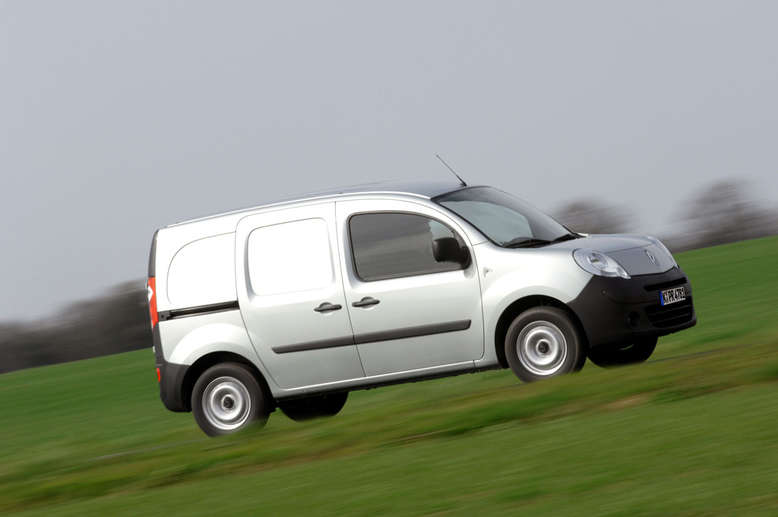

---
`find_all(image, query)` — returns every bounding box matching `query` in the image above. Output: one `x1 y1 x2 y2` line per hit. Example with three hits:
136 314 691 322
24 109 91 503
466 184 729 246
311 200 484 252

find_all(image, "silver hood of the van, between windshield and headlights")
553 234 675 276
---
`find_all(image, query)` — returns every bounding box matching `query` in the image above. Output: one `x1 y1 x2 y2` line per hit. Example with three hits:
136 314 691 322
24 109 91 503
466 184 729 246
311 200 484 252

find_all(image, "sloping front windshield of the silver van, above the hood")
435 187 577 248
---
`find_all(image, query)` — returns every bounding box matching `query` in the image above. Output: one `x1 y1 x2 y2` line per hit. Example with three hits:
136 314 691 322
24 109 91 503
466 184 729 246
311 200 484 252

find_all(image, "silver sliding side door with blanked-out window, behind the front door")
235 202 364 388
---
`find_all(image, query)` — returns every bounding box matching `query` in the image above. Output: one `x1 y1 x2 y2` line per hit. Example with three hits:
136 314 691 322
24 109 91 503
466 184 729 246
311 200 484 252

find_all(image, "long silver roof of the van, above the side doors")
168 181 463 227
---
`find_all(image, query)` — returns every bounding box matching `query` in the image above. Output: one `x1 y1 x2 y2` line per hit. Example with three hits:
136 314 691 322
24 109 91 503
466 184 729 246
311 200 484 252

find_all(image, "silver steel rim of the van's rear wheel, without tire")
202 377 251 431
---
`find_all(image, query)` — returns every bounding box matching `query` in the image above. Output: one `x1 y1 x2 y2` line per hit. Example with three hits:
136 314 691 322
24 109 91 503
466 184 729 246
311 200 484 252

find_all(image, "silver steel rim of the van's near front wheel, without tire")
516 321 567 376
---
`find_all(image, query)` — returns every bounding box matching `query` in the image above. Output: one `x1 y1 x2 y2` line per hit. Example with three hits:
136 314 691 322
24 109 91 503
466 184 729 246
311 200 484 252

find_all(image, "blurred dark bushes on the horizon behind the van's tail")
0 281 152 373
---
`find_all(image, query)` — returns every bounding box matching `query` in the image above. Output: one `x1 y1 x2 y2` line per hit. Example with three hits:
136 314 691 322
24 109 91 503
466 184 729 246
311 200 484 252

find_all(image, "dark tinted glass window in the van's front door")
349 212 462 282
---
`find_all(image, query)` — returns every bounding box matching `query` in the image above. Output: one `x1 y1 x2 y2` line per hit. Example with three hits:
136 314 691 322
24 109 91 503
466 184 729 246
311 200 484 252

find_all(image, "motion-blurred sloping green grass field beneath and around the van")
0 238 778 516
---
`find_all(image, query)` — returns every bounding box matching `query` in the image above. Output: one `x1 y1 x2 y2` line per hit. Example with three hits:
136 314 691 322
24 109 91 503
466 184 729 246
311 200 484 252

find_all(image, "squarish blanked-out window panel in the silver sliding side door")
248 218 335 296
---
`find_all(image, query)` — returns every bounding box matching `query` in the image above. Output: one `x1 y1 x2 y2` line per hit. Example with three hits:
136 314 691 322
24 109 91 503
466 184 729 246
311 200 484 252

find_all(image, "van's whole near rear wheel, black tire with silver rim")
192 363 272 436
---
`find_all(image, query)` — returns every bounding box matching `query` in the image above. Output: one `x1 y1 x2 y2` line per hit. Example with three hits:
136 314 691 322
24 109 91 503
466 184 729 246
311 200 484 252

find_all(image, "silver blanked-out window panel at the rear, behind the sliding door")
167 233 233 307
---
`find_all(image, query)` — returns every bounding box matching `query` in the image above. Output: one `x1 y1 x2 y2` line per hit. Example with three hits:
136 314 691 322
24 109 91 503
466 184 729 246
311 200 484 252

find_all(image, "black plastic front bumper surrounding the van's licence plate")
568 268 697 347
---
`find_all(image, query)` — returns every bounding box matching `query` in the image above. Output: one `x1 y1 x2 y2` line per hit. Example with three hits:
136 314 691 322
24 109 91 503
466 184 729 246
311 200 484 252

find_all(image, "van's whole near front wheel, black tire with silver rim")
505 306 586 382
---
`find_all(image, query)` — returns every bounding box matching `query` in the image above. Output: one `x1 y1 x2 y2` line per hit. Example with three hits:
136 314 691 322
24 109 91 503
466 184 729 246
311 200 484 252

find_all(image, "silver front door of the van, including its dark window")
336 199 484 376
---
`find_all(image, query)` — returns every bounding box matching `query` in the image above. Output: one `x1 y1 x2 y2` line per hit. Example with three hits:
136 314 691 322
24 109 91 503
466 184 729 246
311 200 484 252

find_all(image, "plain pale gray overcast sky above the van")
0 0 778 321
